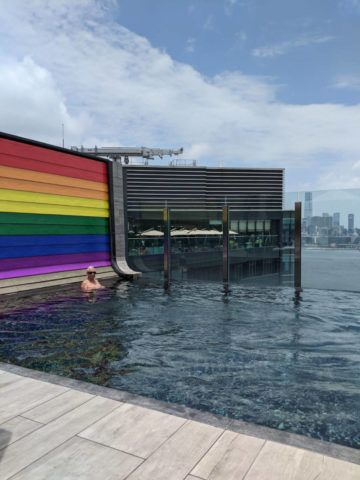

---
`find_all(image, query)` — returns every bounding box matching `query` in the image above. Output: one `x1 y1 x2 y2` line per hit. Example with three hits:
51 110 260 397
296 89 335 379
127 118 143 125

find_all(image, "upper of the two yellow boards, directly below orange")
0 188 109 209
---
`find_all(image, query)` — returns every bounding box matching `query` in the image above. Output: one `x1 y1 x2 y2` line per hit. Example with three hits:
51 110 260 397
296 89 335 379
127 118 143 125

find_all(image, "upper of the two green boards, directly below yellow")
0 212 109 227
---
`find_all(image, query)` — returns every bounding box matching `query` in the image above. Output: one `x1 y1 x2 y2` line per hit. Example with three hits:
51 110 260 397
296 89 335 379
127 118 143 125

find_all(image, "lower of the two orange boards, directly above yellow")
0 177 108 200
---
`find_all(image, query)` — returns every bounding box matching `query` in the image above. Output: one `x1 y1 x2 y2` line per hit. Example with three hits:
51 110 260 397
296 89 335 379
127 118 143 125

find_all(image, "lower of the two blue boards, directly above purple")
0 243 109 258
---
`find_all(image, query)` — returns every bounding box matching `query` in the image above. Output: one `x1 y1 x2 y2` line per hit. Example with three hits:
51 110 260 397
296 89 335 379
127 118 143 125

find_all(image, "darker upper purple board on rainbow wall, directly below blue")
0 252 110 272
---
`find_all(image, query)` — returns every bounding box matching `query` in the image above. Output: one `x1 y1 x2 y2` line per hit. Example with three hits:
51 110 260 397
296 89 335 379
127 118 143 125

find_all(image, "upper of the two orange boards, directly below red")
0 165 108 192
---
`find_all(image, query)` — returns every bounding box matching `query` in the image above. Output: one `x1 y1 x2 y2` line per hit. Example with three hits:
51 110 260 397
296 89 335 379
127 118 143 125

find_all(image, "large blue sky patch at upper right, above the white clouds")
116 0 360 105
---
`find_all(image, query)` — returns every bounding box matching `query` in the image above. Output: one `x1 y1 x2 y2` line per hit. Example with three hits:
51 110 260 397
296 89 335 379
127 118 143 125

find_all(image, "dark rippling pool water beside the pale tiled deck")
0 279 360 448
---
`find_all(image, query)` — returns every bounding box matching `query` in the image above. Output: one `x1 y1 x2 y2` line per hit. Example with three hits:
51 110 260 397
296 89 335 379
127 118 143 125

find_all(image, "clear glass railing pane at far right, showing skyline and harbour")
285 189 360 291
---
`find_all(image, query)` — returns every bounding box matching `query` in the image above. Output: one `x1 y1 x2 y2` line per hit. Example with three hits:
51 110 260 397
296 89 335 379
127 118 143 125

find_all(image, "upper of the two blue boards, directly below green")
0 235 109 247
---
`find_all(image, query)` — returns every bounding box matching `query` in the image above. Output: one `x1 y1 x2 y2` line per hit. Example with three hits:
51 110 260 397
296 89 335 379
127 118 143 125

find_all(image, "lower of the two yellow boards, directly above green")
0 201 109 218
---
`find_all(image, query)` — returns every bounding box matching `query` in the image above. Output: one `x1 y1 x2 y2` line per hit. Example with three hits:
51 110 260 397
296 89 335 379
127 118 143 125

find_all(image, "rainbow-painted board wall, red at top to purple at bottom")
0 133 110 279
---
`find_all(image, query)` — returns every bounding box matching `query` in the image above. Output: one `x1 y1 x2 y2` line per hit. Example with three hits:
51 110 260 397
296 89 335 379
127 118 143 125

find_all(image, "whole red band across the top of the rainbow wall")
0 138 107 183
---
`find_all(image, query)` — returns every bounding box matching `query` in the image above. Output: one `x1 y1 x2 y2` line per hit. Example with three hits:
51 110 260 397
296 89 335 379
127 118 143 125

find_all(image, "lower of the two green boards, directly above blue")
0 224 109 235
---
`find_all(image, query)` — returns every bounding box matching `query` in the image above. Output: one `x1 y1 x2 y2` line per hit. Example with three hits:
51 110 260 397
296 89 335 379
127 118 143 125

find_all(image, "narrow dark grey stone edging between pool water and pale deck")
0 362 360 465
